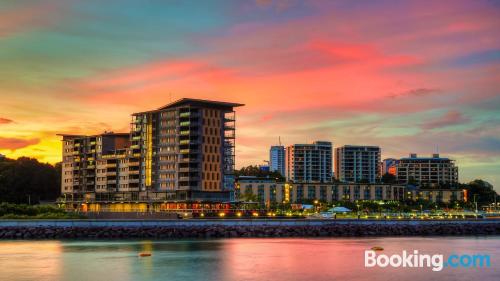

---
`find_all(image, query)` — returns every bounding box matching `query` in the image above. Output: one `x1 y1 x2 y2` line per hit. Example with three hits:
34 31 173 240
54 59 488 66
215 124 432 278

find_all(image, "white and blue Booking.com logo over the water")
365 250 491 271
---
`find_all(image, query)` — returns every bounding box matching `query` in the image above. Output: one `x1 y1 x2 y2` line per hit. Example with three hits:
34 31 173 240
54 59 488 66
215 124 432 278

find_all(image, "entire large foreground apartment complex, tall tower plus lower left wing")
62 99 242 201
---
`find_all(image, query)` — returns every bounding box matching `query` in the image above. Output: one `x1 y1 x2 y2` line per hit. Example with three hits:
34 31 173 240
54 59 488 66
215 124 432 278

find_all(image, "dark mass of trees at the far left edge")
0 157 61 204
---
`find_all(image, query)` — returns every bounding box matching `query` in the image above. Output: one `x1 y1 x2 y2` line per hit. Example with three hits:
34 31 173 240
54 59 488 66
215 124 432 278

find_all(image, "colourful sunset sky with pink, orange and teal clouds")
0 0 500 190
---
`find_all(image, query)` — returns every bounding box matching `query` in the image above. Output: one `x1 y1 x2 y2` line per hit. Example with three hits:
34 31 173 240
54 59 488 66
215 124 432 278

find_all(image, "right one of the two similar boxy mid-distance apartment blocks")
335 145 381 183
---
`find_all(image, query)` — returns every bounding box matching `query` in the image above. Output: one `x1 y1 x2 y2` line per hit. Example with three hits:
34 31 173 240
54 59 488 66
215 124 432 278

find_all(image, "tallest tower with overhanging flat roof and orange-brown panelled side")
131 99 242 200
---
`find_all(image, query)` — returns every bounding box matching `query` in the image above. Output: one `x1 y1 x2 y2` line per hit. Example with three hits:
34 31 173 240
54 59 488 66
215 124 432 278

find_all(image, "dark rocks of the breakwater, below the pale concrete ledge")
0 221 500 239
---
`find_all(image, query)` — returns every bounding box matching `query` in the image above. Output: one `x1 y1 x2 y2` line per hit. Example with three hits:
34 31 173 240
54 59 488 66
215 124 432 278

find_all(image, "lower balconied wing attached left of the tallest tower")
61 133 139 197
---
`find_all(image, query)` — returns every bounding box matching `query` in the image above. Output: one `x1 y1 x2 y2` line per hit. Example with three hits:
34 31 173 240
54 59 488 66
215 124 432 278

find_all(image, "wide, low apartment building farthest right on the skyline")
396 154 458 185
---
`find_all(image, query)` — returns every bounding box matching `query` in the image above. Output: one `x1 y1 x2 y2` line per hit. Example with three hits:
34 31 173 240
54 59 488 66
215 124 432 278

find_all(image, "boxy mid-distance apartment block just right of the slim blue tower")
285 141 332 182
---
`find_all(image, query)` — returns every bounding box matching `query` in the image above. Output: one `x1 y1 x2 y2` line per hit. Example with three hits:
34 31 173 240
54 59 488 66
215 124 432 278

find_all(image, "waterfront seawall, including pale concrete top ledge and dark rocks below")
0 219 500 239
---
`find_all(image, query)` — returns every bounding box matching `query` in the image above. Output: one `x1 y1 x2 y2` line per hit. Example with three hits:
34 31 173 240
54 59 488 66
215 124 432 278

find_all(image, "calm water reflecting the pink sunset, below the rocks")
0 237 500 281
